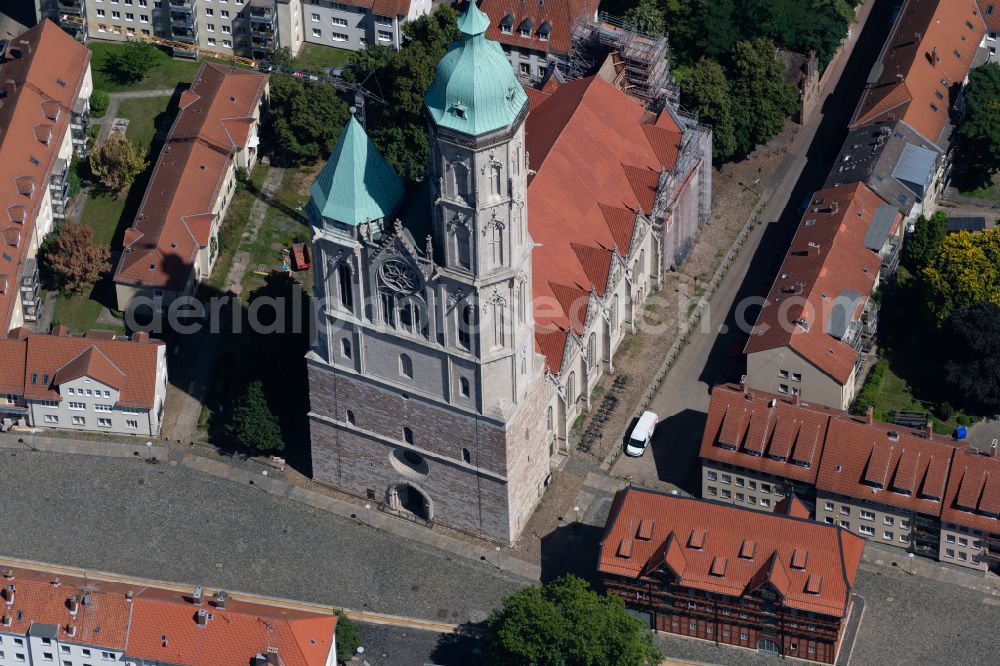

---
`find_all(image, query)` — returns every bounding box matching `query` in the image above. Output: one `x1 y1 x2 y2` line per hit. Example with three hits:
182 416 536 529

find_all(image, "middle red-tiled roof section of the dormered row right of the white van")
816 415 957 516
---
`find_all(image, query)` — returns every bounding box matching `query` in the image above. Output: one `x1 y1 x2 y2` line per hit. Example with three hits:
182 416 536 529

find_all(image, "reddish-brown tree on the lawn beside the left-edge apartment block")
43 224 111 291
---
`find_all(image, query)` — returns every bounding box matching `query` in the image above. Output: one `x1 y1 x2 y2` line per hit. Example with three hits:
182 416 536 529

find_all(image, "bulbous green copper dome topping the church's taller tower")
424 0 528 136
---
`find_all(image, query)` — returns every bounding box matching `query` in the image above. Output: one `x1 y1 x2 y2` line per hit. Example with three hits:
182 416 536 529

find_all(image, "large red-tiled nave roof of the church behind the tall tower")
525 76 679 372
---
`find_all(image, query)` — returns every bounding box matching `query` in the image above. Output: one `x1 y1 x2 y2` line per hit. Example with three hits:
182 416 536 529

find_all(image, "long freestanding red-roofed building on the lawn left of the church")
114 62 268 312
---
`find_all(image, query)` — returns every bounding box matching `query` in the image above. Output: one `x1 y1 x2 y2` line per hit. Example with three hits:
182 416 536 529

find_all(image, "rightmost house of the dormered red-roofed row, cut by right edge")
938 447 1000 571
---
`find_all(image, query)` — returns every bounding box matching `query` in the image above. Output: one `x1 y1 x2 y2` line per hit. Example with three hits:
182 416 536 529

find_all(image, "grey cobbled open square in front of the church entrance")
0 451 526 620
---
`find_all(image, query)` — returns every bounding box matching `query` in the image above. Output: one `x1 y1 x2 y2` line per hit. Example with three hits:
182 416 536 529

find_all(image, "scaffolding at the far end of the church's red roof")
568 12 677 103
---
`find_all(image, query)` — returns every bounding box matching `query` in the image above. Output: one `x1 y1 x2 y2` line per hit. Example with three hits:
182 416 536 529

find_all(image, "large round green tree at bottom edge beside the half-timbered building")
483 575 662 666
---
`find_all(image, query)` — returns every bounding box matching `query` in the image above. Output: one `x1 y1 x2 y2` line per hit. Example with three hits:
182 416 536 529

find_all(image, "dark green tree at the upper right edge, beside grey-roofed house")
959 62 1000 184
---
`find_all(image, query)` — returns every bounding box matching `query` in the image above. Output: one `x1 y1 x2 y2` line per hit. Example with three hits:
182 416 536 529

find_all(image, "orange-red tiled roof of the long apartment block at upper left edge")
0 19 90 333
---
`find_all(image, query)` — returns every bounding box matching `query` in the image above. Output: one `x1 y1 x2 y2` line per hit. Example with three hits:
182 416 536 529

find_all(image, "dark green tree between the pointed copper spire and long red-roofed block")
264 74 347 164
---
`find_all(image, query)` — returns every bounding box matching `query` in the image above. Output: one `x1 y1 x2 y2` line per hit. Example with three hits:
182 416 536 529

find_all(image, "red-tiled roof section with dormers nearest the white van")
699 384 843 484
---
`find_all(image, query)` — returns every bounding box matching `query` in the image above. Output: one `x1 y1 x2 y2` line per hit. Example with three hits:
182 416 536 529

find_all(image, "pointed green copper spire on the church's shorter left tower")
306 109 403 226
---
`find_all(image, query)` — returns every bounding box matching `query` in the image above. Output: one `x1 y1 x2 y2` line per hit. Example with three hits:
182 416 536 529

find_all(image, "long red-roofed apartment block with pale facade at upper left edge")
0 21 93 335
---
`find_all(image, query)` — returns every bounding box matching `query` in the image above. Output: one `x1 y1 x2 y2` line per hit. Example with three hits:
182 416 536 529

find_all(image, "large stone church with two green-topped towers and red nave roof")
307 3 711 543
